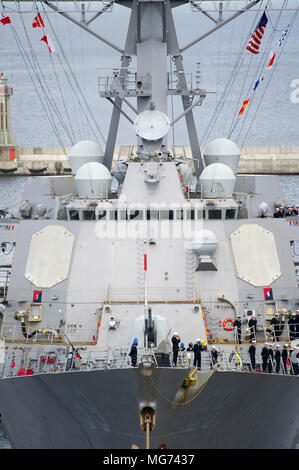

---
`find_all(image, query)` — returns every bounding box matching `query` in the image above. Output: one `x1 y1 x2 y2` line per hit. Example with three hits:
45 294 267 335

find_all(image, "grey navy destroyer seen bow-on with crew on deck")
0 0 299 449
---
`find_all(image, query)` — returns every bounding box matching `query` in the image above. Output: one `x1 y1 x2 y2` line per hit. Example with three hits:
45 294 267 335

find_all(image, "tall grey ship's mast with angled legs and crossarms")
2 0 268 172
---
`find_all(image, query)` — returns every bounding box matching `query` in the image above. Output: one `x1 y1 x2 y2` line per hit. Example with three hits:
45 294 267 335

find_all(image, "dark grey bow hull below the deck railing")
0 368 299 449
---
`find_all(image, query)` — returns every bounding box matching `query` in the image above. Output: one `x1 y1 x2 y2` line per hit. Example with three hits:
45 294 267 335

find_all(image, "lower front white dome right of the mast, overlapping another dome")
199 163 236 199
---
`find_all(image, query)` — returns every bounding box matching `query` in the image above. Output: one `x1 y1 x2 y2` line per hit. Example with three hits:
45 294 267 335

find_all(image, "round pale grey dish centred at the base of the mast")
134 109 170 141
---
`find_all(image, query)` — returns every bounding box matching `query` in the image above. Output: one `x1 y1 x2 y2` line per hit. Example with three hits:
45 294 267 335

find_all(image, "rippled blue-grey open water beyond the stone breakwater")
0 0 299 146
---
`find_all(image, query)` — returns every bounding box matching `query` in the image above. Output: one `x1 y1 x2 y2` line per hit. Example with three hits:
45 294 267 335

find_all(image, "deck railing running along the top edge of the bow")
0 345 299 378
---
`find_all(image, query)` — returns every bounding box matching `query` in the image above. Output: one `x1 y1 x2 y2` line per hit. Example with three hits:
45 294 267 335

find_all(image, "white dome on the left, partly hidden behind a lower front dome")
69 140 104 174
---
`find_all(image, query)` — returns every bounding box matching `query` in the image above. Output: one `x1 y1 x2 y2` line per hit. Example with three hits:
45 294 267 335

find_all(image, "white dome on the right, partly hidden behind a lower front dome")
204 138 240 173
